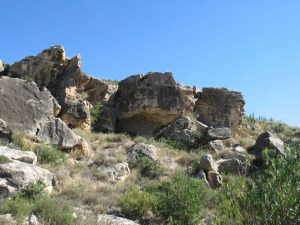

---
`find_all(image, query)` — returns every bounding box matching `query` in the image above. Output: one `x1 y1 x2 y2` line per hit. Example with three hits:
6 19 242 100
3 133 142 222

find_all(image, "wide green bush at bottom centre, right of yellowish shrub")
147 173 213 225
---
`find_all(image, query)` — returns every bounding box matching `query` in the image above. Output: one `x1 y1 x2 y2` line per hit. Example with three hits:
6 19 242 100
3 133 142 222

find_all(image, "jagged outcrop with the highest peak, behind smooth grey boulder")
8 45 90 129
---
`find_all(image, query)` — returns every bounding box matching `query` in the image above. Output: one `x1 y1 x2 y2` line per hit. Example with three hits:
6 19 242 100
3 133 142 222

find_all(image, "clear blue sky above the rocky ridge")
0 0 300 126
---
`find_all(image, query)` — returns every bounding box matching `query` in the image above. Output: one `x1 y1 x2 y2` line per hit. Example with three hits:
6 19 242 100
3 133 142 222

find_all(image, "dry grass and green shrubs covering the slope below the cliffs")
0 118 300 225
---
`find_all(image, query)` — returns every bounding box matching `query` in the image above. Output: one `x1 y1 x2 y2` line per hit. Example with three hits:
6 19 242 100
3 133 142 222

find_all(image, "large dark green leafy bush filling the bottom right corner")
220 143 300 225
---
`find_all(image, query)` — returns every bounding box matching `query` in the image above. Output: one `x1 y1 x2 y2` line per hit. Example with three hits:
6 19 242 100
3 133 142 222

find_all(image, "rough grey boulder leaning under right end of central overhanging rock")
156 116 201 148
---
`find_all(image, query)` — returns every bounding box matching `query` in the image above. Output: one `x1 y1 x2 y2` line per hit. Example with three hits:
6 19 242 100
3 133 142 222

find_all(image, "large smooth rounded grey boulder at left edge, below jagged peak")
0 77 56 136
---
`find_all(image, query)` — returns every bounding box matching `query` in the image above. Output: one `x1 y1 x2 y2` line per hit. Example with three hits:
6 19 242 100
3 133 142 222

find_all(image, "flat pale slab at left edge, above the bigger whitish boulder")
0 146 37 165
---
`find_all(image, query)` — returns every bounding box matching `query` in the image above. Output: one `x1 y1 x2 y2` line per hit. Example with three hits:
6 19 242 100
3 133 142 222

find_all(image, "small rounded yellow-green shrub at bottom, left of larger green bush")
118 187 155 220
